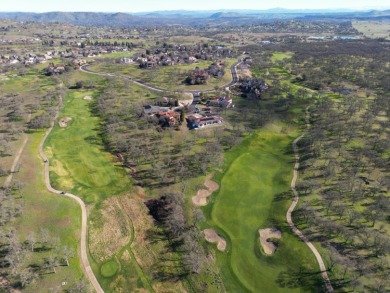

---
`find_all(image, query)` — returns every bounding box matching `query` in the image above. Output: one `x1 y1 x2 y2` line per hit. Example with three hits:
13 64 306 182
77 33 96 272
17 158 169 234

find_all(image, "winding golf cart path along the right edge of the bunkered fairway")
286 107 334 293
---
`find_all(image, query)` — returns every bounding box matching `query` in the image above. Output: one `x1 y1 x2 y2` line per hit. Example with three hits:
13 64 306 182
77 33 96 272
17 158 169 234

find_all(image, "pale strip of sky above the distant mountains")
0 0 390 12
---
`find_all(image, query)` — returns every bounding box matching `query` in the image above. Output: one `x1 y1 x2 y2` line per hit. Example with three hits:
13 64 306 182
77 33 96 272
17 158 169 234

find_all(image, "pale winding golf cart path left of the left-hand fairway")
39 101 104 293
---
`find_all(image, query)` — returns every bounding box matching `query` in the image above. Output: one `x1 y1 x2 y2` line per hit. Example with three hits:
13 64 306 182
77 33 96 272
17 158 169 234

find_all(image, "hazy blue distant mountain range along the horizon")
0 8 390 26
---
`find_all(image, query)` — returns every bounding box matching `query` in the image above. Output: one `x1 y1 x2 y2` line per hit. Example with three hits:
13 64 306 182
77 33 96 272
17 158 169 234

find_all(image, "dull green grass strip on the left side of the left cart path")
14 132 83 292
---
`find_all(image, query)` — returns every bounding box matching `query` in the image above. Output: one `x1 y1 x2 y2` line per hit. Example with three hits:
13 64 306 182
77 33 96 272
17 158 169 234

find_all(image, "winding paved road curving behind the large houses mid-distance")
80 62 241 94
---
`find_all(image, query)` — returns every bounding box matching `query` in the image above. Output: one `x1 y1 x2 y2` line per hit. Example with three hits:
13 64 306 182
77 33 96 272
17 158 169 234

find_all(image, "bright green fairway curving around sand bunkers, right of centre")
211 124 321 292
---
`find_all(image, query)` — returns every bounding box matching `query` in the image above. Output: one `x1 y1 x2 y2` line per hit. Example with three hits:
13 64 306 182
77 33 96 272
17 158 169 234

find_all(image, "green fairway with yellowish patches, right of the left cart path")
45 91 131 203
